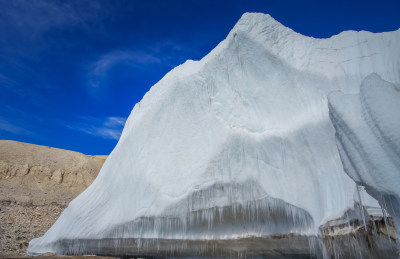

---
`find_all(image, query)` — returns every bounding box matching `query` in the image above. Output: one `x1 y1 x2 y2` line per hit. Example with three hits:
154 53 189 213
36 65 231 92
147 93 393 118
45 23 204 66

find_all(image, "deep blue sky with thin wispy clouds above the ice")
0 0 400 155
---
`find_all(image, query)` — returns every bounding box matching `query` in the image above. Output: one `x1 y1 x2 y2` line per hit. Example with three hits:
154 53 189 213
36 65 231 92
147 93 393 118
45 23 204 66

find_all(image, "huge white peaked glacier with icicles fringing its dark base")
27 13 400 258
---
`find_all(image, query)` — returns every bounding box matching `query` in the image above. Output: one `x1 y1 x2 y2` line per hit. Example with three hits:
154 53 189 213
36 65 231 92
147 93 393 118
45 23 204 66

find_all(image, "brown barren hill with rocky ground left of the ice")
0 140 107 257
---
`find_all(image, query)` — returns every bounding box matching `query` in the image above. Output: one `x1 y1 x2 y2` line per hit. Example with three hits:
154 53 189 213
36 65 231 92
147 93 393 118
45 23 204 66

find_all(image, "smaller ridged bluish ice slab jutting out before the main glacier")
329 74 400 244
